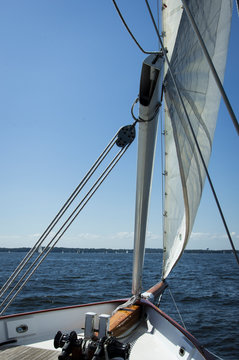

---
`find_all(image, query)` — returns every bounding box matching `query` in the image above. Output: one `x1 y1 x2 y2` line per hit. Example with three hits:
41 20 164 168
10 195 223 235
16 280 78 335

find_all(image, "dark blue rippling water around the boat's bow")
0 251 239 360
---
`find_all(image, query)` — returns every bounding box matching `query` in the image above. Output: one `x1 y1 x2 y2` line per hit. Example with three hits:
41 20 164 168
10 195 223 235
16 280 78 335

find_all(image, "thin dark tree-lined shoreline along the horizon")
0 247 235 254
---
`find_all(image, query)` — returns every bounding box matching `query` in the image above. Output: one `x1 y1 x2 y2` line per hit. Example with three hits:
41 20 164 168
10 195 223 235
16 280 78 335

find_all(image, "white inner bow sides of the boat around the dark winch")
0 300 214 360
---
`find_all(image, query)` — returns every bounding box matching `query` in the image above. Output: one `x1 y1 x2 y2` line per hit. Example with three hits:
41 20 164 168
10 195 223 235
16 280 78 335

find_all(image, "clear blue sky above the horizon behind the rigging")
0 0 239 249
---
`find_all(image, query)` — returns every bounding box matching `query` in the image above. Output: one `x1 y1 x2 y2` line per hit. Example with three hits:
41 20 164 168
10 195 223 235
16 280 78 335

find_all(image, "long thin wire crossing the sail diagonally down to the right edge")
145 0 239 265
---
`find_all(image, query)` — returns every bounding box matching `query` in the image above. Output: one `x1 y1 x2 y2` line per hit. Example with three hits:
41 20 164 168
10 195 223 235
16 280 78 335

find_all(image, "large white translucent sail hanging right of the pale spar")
162 0 232 278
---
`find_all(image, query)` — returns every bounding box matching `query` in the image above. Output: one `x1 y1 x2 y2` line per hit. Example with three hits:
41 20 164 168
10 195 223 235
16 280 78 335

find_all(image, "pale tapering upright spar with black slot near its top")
132 54 163 295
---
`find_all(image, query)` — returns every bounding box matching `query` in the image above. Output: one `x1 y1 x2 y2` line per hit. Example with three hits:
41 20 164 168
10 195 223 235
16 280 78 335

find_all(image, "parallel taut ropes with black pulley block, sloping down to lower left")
0 121 137 315
